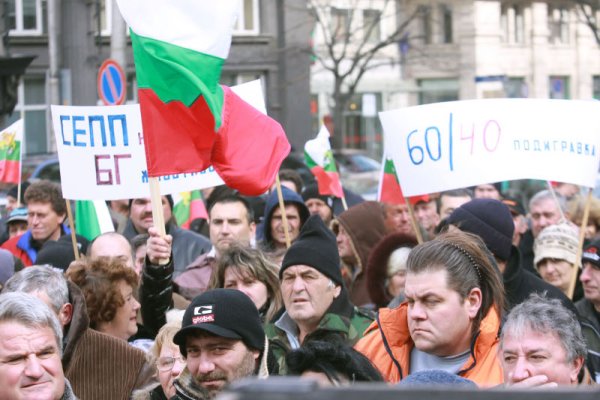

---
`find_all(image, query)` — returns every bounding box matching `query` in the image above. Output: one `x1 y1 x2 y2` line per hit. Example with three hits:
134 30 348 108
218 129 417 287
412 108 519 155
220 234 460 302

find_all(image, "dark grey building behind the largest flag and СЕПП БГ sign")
4 0 311 155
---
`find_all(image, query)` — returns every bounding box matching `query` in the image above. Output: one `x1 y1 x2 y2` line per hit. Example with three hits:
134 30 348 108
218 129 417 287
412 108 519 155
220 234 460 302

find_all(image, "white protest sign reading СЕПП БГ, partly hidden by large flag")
51 80 265 200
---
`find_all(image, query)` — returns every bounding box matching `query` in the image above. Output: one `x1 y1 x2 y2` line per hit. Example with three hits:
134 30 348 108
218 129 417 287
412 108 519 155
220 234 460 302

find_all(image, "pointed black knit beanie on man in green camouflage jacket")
279 215 343 285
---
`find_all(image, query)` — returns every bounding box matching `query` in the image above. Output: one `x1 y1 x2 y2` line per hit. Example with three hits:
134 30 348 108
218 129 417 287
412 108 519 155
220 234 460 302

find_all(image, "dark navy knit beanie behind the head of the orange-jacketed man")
448 199 515 261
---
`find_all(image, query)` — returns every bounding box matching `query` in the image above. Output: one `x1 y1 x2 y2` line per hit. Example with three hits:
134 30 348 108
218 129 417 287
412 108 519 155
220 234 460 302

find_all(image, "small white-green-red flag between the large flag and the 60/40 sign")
304 125 344 198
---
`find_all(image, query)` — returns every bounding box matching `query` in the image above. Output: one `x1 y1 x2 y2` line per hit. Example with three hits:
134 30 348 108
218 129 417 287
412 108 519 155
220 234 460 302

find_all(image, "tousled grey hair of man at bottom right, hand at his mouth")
500 293 587 362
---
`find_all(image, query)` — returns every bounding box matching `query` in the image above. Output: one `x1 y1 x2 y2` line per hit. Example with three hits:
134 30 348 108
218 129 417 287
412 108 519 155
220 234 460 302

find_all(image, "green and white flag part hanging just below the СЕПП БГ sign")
75 200 115 241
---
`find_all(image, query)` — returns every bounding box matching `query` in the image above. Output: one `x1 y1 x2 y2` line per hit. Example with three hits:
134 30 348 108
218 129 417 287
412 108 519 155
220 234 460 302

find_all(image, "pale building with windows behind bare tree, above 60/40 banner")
311 0 600 157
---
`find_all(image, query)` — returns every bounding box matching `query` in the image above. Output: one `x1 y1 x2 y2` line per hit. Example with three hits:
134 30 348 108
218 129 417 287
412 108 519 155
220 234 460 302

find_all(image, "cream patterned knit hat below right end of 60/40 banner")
533 222 581 268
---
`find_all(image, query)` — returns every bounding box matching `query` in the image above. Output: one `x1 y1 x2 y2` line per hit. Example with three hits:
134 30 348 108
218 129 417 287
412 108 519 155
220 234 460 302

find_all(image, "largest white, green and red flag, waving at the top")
117 0 290 195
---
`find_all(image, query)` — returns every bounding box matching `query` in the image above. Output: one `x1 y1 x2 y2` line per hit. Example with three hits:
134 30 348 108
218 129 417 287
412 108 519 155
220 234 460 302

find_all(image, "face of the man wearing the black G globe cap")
186 334 260 398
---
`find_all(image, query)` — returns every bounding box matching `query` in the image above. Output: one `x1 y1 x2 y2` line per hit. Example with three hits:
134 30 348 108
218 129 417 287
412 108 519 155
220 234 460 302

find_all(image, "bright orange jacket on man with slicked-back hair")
355 303 504 387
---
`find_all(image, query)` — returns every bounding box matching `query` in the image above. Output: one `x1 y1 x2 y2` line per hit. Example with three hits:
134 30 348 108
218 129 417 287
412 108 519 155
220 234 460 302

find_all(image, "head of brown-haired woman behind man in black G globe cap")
209 244 283 322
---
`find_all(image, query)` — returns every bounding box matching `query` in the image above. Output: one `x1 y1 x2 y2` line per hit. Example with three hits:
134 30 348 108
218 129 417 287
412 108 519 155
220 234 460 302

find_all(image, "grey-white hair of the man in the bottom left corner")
0 292 63 357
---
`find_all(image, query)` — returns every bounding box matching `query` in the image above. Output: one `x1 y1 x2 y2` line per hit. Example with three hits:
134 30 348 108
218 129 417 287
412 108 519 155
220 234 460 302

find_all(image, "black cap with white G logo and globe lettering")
173 289 265 356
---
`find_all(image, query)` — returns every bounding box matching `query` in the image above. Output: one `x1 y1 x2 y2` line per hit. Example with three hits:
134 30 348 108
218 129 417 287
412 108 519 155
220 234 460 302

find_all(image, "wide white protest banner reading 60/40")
379 99 600 196
